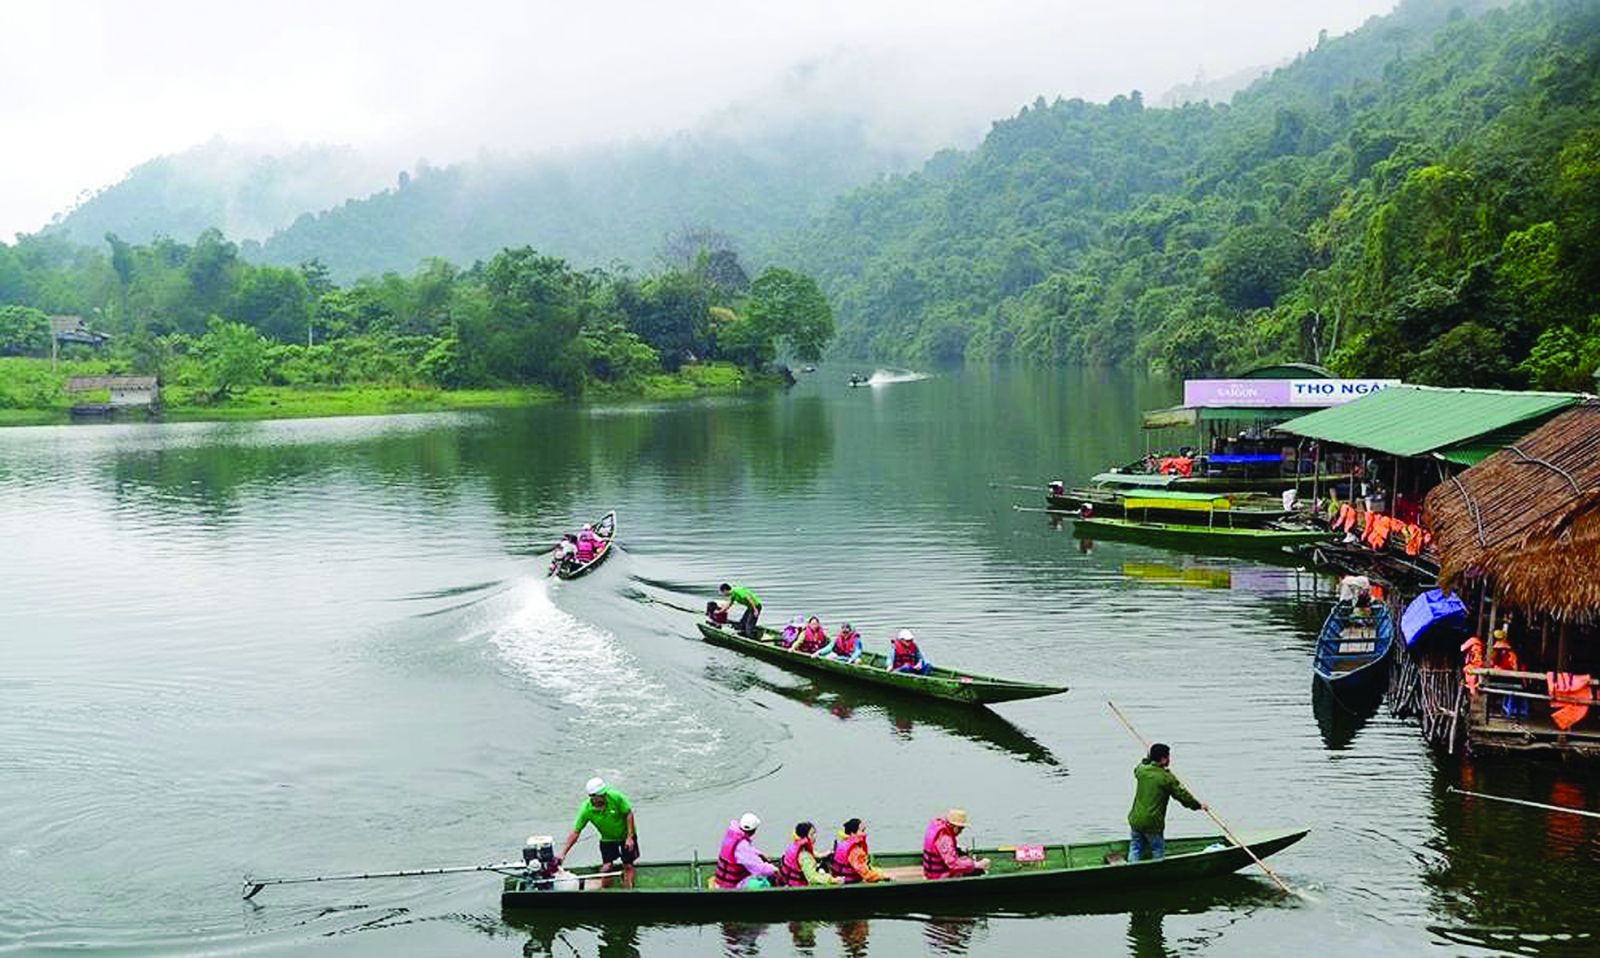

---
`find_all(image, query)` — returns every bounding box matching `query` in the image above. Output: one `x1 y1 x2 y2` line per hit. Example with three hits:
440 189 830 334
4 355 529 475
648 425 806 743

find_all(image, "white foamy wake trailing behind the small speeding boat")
490 579 722 758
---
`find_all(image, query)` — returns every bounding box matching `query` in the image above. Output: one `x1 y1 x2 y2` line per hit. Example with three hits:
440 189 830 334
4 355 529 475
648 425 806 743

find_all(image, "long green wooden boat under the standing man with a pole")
501 828 1307 921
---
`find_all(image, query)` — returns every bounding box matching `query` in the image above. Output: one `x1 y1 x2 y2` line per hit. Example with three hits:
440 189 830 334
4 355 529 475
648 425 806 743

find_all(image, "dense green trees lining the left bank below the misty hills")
0 230 834 406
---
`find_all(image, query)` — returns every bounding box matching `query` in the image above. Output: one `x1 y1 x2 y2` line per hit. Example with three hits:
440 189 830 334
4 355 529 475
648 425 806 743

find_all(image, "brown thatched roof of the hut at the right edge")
1426 400 1600 622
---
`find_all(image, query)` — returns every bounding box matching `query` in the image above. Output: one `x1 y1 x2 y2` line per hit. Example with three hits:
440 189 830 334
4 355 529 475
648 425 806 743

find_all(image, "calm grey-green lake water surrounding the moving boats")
0 369 1600 956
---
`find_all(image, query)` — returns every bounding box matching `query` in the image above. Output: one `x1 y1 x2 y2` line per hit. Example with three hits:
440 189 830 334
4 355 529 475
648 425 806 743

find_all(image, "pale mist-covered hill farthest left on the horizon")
43 139 394 246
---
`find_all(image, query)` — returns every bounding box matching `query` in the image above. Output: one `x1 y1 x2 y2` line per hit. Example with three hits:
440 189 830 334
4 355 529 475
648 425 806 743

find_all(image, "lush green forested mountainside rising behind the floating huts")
792 0 1600 385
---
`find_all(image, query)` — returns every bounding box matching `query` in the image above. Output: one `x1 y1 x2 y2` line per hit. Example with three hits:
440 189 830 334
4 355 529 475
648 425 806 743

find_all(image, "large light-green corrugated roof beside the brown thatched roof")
1277 385 1582 456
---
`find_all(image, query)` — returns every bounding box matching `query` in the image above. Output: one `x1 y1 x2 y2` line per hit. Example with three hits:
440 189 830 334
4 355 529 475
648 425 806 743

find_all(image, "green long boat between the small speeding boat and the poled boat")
699 622 1067 705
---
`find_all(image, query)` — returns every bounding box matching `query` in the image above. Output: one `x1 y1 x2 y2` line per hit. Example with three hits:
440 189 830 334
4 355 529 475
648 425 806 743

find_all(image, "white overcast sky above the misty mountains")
0 0 1394 237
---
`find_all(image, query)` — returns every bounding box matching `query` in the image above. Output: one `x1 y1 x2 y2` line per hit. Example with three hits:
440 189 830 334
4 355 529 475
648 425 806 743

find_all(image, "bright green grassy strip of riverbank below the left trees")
0 357 776 425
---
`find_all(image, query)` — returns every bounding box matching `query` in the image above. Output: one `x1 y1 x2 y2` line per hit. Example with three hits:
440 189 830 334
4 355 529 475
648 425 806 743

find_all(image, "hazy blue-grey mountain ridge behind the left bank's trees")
245 115 918 278
